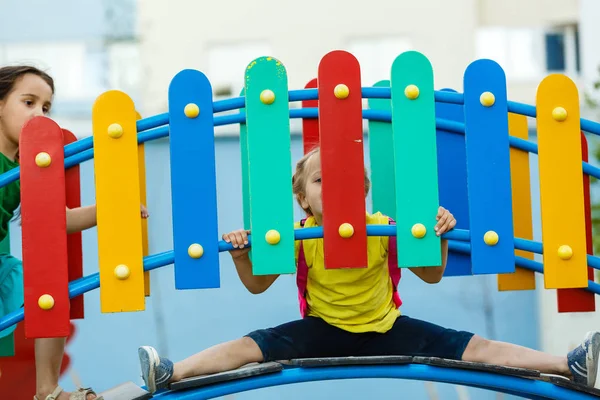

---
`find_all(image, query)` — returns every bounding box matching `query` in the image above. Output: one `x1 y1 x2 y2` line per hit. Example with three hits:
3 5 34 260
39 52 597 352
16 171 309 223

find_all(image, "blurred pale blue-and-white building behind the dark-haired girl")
0 0 142 136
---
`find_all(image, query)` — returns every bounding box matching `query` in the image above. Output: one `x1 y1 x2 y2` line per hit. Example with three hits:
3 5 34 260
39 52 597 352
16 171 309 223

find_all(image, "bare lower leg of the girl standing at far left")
35 338 96 400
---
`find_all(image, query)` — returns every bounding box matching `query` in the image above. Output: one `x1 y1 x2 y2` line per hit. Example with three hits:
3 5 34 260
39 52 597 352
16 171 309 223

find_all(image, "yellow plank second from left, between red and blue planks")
92 90 145 312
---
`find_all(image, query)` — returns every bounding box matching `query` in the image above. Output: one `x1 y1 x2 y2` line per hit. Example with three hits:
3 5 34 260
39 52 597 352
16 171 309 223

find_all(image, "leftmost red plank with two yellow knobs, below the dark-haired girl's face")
19 117 70 338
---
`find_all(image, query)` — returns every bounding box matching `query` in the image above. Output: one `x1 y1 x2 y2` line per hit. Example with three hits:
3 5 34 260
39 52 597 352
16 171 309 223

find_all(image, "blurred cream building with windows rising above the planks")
139 0 600 120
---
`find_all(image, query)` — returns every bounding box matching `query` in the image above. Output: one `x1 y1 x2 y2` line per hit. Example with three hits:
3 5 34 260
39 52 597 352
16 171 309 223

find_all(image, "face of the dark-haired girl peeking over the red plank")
0 74 53 146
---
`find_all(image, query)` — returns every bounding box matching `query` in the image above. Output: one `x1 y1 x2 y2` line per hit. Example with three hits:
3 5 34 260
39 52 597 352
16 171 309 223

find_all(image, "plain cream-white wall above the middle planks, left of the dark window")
139 0 477 114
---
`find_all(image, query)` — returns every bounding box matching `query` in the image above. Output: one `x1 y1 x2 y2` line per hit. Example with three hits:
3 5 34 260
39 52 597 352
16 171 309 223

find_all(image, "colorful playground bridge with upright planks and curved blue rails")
0 51 600 399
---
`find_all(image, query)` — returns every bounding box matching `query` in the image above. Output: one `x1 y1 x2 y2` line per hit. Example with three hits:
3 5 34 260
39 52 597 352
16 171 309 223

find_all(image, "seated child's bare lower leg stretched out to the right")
463 335 571 378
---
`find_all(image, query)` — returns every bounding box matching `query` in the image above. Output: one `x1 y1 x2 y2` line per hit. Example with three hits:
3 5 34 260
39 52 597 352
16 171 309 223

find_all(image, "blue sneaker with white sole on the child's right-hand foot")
567 332 600 387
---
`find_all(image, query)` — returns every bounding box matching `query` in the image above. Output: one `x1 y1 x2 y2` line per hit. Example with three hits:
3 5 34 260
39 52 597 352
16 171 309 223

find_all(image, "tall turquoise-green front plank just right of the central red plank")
391 51 442 268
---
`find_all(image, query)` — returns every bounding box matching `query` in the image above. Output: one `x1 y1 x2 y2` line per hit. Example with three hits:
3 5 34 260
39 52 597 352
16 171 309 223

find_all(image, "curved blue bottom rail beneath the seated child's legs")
146 364 597 400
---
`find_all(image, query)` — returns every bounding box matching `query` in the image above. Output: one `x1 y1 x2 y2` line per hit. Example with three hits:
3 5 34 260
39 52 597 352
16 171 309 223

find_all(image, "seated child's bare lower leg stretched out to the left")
171 337 263 382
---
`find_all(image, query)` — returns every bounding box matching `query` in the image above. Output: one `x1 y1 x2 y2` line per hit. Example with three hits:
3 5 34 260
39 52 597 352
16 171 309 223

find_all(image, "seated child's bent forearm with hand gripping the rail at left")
223 229 279 294
